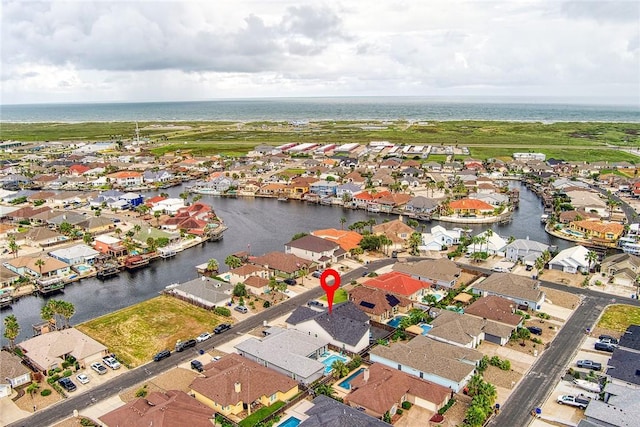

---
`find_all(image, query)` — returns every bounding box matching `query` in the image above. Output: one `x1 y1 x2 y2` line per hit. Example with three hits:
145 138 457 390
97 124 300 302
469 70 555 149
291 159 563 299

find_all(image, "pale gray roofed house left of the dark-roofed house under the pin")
235 327 329 384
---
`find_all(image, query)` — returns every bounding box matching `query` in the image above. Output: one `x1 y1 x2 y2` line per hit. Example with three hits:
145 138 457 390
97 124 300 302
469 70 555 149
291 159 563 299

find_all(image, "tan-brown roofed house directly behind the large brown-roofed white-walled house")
429 310 516 348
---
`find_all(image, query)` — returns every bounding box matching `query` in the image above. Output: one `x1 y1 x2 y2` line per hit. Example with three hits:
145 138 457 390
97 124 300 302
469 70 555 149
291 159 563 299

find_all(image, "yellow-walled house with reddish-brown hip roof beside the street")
189 353 298 415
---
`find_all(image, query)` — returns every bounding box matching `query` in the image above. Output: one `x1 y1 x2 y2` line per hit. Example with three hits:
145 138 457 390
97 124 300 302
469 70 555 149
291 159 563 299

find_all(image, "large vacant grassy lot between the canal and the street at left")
78 295 229 367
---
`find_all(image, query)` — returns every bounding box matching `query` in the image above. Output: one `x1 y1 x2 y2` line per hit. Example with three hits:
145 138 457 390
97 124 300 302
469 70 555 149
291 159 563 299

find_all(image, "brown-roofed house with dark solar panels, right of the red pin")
349 286 413 323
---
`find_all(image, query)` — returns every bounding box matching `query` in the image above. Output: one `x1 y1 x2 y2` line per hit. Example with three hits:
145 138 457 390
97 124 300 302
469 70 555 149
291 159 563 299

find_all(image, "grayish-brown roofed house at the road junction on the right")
472 273 544 311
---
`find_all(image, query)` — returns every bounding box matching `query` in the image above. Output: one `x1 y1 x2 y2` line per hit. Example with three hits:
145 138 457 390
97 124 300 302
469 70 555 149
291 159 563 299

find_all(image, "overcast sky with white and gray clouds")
0 0 640 106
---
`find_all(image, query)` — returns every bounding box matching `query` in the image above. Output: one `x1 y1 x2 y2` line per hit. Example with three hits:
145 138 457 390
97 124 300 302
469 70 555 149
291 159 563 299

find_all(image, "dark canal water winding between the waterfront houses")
0 182 570 345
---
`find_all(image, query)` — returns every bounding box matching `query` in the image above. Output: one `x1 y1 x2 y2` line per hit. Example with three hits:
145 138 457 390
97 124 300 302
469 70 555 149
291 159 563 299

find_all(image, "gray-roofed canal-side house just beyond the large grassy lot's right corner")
167 276 233 308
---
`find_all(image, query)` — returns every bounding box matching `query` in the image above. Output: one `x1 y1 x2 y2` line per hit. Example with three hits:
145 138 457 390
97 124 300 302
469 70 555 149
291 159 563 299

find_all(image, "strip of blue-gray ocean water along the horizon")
0 97 640 123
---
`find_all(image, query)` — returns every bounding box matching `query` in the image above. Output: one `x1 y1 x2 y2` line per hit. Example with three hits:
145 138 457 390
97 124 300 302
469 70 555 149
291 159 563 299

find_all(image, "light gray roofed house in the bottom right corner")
584 383 640 427
